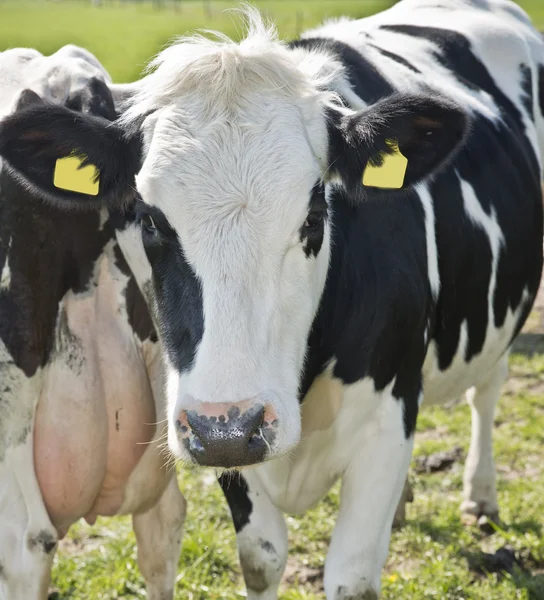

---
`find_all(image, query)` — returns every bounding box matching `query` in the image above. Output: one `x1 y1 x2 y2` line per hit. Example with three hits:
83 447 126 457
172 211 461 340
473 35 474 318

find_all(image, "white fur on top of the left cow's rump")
0 45 111 117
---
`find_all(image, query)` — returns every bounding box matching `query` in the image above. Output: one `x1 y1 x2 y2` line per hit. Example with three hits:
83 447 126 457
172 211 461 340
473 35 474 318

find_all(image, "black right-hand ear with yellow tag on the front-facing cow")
329 94 469 198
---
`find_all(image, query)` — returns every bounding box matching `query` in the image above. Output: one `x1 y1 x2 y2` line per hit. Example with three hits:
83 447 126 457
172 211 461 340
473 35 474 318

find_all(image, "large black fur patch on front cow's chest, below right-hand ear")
300 188 434 437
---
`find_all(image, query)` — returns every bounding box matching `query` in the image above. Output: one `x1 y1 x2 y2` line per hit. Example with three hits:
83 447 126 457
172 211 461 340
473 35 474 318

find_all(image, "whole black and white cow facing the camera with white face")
0 0 544 600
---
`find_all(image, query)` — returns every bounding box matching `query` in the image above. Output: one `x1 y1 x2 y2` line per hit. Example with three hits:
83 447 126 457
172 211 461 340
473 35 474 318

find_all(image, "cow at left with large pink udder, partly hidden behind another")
0 46 185 600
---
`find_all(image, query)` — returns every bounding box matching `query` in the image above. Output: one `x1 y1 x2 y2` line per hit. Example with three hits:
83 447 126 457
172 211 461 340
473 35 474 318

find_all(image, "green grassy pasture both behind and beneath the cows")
0 0 544 600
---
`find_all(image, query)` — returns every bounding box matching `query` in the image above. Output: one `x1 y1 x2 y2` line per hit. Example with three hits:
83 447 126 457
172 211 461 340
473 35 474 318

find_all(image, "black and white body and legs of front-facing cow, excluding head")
221 0 544 600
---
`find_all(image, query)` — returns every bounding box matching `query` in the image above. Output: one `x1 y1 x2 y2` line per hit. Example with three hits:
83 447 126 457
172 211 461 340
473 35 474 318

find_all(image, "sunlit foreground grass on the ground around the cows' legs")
47 355 544 600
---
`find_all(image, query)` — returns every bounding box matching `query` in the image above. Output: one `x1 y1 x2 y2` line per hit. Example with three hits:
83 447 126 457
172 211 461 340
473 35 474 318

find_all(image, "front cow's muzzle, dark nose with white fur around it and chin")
168 384 301 471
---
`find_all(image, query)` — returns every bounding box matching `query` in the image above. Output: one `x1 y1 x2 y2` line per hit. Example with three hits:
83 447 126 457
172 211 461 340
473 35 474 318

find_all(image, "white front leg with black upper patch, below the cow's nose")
219 473 287 600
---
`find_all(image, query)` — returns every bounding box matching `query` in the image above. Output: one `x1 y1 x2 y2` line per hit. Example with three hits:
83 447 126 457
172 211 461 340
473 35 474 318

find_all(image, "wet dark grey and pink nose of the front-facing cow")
176 401 277 468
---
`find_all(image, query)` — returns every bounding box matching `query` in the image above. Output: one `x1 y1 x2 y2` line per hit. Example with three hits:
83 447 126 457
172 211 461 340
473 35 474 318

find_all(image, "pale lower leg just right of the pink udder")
132 473 186 600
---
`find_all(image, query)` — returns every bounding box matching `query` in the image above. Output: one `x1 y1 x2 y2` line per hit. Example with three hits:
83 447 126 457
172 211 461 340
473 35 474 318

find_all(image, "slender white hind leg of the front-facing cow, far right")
461 354 508 524
